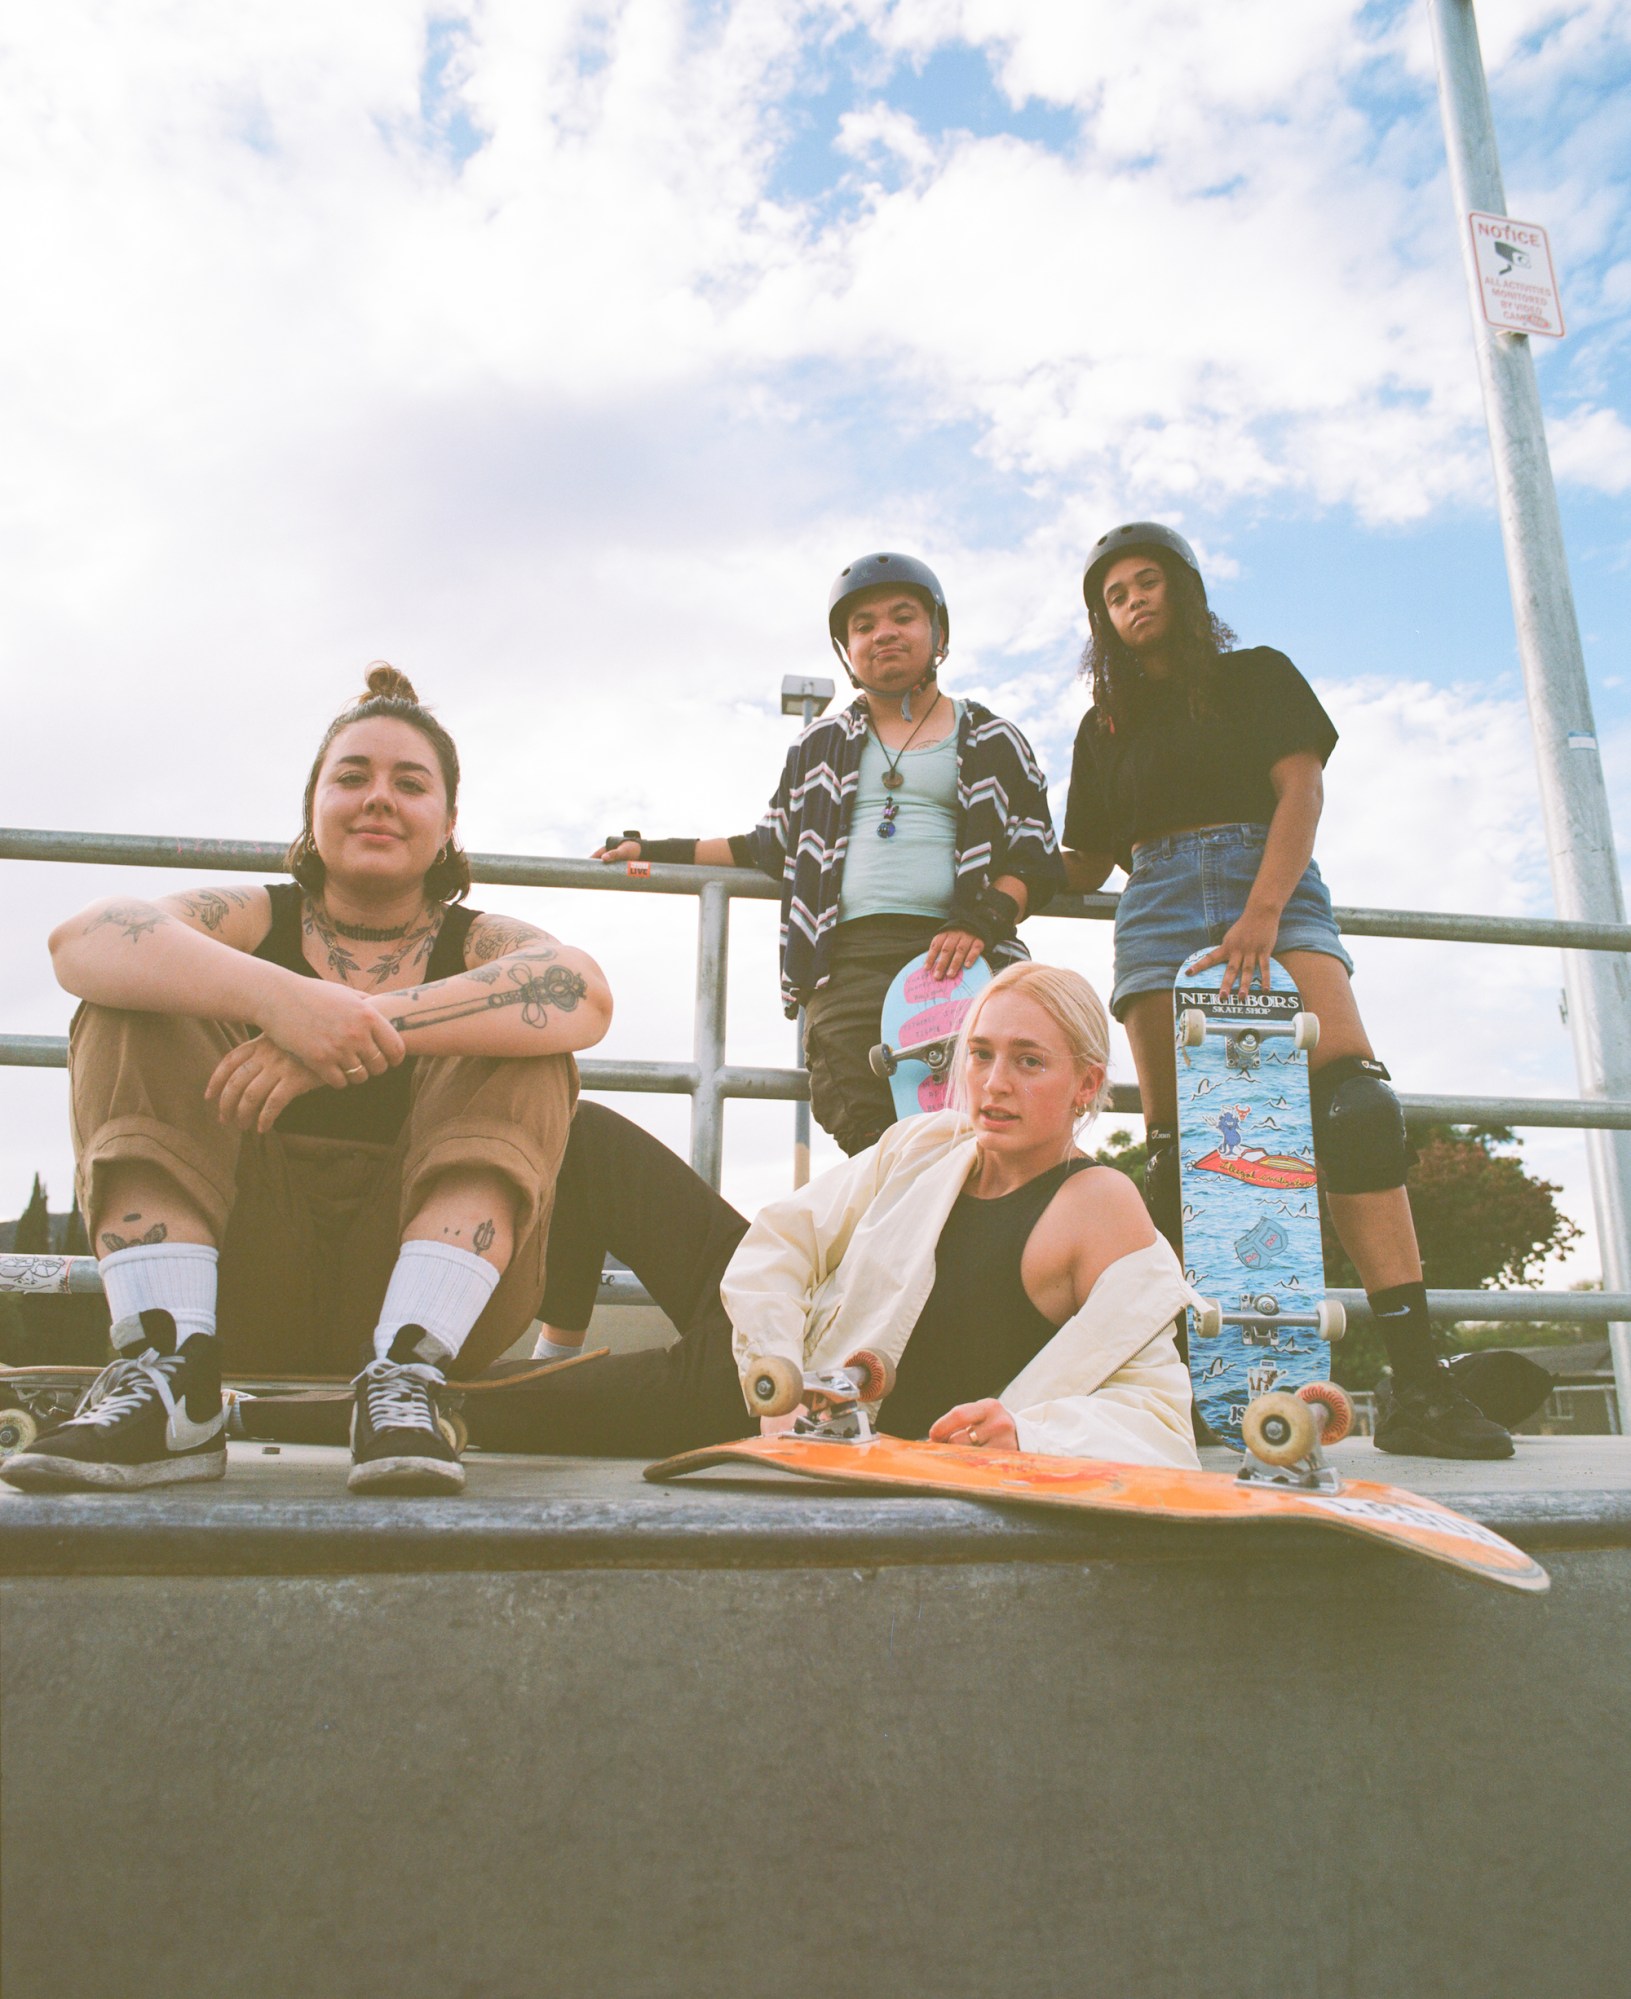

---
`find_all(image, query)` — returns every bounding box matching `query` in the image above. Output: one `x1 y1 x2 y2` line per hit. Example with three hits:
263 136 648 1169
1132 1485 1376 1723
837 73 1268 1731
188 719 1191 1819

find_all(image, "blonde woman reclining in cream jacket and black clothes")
459 964 1197 1467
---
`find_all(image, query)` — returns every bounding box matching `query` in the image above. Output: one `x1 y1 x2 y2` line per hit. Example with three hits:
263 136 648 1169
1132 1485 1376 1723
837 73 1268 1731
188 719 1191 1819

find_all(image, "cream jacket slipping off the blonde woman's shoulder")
720 1111 1199 1469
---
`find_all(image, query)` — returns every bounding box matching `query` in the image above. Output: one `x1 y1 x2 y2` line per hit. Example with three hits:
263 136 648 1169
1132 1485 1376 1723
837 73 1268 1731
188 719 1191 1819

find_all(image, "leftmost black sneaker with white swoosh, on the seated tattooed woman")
0 1311 226 1491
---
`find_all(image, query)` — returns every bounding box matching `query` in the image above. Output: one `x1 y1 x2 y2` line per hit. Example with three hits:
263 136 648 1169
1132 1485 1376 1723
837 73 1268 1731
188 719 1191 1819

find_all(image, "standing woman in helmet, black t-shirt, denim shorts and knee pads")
1065 520 1513 1457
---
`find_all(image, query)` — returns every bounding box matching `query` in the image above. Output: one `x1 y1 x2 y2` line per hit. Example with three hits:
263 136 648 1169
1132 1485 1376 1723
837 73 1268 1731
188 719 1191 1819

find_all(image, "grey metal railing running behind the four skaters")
0 828 1631 1367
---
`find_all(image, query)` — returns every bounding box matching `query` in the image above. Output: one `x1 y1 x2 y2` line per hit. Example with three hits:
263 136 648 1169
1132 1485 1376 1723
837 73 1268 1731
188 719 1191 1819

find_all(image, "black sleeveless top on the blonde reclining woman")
879 1159 1093 1437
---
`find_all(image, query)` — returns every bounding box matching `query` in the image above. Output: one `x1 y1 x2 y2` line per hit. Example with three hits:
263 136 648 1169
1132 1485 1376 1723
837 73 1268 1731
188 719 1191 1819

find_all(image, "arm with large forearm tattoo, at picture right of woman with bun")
374 916 612 1055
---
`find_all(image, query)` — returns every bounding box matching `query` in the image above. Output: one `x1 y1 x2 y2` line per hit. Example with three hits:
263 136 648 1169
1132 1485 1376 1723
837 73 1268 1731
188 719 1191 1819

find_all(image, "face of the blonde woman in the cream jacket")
963 992 1103 1165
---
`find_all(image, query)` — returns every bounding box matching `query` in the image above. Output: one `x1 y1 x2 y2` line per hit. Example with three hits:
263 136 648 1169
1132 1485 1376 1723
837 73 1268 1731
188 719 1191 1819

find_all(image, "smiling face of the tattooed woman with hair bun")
312 716 454 894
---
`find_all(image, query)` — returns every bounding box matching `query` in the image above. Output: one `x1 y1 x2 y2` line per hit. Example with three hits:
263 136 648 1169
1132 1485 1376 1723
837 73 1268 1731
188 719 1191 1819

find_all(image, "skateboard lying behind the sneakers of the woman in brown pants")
0 1347 610 1457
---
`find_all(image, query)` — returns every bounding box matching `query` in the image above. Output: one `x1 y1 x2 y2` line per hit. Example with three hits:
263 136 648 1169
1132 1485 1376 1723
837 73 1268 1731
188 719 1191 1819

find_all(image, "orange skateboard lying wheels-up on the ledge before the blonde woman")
646 1355 1551 1591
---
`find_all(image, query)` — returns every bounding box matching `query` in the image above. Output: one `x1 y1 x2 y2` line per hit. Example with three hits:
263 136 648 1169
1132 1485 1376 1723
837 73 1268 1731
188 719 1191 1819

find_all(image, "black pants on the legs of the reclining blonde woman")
464 1101 758 1457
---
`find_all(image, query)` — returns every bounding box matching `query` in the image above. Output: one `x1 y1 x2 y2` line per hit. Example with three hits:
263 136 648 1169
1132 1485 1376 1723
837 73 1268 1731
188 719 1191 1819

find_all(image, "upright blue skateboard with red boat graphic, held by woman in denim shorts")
1173 952 1343 1443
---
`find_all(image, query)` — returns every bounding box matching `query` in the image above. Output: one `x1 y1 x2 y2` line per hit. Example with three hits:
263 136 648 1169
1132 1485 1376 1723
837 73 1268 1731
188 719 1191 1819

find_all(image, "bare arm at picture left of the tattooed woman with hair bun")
50 888 406 1089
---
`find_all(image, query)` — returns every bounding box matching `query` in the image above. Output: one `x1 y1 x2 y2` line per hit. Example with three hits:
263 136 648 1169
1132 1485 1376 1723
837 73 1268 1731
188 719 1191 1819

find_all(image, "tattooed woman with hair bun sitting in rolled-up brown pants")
4 664 612 1491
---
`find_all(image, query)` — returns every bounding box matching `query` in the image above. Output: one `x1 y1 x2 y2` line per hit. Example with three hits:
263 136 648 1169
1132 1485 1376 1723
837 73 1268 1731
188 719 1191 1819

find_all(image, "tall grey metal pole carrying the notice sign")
1427 0 1631 1409
